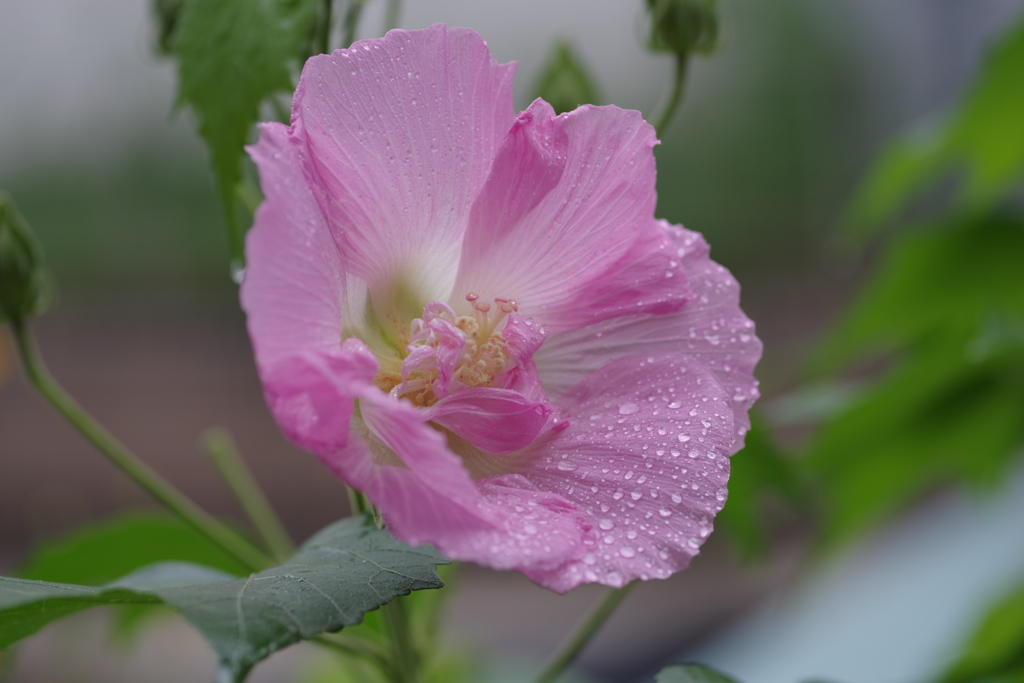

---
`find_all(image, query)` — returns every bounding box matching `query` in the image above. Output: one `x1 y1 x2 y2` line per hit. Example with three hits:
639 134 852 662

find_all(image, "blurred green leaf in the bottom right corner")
939 585 1024 683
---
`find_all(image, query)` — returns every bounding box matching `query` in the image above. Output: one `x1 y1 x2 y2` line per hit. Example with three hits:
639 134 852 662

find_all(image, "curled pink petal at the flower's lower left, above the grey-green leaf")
339 390 588 570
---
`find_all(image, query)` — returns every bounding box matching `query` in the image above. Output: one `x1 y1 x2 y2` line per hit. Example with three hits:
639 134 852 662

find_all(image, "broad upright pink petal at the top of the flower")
292 25 515 306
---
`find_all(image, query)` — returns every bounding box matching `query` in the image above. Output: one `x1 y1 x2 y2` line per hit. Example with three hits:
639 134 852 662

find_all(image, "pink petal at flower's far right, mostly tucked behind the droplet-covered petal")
534 221 761 452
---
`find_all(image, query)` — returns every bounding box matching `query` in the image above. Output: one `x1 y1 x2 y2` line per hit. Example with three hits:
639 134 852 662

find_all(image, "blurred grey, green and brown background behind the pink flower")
0 0 1024 683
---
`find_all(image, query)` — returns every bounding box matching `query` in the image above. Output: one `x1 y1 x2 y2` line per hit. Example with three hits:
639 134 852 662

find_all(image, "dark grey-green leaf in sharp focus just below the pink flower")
0 515 447 683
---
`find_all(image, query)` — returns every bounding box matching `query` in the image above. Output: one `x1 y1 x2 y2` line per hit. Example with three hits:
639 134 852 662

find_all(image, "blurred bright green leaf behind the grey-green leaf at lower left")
17 513 247 586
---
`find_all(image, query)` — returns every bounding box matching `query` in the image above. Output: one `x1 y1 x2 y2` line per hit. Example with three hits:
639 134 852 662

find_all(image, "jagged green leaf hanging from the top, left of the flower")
173 0 317 258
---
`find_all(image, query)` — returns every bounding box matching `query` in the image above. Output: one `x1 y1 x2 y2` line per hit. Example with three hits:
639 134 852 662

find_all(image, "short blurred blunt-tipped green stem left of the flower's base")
203 429 295 562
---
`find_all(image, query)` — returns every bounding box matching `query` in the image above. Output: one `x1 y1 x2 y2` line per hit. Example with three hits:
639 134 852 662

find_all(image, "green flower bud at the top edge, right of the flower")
647 0 718 55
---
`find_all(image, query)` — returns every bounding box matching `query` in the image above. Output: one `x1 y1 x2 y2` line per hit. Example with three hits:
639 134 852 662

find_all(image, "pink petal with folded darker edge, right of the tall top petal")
452 100 689 332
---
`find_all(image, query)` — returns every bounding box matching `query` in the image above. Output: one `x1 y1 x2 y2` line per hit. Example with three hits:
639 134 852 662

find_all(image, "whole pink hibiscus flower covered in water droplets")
242 25 761 592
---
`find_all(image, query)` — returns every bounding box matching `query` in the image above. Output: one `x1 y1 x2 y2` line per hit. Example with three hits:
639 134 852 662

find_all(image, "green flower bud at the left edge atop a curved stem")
0 193 50 323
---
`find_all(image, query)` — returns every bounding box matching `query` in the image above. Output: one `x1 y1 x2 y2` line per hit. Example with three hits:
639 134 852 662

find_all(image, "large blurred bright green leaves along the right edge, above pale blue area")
801 13 1024 544
